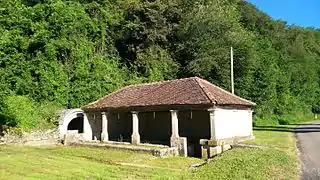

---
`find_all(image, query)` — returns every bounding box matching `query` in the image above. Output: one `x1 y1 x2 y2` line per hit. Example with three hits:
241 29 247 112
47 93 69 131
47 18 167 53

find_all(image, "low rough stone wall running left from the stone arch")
0 129 60 146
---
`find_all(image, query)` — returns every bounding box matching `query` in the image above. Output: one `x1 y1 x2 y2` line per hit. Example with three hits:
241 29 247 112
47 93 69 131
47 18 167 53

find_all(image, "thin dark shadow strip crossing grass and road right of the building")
253 123 320 133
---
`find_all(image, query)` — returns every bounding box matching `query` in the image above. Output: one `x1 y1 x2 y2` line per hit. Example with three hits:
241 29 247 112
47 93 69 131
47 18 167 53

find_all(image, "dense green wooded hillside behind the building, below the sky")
0 0 320 127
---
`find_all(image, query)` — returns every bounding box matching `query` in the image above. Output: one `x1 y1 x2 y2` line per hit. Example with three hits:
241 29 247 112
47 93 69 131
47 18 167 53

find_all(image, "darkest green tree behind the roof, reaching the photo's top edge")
116 0 179 81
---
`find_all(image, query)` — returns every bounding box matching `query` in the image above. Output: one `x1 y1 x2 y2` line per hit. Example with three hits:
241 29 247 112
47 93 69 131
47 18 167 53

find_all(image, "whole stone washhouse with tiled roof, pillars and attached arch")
59 77 255 157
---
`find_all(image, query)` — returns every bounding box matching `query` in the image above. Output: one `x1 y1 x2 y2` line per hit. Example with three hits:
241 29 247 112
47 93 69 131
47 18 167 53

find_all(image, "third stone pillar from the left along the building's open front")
170 110 180 147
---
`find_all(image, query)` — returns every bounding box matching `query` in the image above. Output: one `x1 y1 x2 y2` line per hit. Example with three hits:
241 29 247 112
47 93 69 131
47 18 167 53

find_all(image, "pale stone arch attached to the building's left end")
59 109 92 141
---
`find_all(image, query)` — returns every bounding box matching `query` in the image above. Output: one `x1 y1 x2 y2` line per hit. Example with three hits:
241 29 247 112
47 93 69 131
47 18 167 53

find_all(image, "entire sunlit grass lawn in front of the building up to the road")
0 127 299 179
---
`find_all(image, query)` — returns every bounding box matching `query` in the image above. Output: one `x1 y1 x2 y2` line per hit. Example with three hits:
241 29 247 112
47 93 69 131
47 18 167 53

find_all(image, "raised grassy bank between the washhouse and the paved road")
192 126 299 179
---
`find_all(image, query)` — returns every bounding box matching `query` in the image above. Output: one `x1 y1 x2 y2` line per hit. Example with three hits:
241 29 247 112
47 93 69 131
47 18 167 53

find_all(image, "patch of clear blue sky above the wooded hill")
248 0 320 28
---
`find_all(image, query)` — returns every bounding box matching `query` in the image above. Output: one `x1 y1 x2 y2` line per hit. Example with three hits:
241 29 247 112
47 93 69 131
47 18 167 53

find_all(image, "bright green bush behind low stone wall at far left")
1 95 57 131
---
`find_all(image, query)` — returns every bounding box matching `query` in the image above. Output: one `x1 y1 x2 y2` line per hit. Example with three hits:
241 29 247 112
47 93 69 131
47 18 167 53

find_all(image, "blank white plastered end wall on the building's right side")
214 107 252 139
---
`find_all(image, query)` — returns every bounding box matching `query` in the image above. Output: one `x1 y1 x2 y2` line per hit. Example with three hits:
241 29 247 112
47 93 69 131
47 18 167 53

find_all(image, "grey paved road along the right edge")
295 122 320 180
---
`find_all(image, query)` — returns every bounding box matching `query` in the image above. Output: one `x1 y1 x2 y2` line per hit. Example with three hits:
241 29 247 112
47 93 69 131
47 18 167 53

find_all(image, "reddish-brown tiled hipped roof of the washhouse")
86 77 255 109
